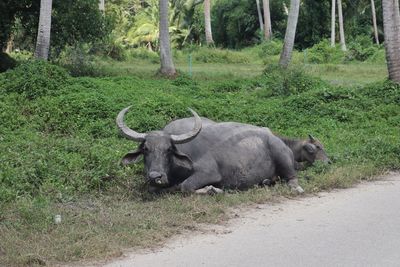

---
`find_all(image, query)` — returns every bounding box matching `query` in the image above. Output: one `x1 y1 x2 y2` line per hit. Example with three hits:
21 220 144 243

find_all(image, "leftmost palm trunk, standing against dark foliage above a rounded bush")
35 0 52 60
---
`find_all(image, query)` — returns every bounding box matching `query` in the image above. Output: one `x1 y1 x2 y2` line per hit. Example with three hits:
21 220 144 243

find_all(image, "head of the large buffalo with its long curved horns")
116 106 202 187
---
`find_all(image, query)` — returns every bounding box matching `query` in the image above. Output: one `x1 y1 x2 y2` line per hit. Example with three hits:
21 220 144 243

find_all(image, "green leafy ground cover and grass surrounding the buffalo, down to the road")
0 57 400 265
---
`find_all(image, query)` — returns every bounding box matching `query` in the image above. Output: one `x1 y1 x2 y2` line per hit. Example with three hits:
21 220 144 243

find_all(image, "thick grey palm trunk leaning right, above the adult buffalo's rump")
279 0 300 68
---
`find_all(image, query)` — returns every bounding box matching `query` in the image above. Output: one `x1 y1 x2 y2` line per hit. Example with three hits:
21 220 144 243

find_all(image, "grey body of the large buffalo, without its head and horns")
163 118 302 192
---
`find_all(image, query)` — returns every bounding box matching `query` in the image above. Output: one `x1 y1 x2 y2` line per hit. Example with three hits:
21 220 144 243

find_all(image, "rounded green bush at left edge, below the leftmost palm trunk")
0 61 70 99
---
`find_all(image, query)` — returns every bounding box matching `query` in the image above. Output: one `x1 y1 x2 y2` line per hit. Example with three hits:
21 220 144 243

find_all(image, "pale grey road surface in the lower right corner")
97 174 400 267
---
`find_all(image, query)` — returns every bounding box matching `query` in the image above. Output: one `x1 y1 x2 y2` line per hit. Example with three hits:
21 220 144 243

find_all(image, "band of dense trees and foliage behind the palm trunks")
0 0 382 56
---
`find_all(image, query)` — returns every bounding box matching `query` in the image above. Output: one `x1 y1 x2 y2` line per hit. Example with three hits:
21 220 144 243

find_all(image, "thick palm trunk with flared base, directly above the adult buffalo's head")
159 0 176 76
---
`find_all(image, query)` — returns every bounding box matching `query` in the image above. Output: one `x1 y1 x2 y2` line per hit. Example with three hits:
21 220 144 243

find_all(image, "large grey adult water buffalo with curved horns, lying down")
117 107 303 193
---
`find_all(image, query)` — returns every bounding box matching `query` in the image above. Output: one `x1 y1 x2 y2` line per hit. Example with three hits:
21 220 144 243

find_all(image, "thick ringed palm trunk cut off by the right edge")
382 0 400 83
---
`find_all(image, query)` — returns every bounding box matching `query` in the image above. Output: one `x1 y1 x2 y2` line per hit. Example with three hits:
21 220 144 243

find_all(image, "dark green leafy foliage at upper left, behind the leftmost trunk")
0 0 108 56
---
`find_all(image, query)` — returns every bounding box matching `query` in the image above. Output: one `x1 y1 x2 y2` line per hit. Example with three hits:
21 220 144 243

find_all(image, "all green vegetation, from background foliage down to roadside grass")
0 0 400 265
